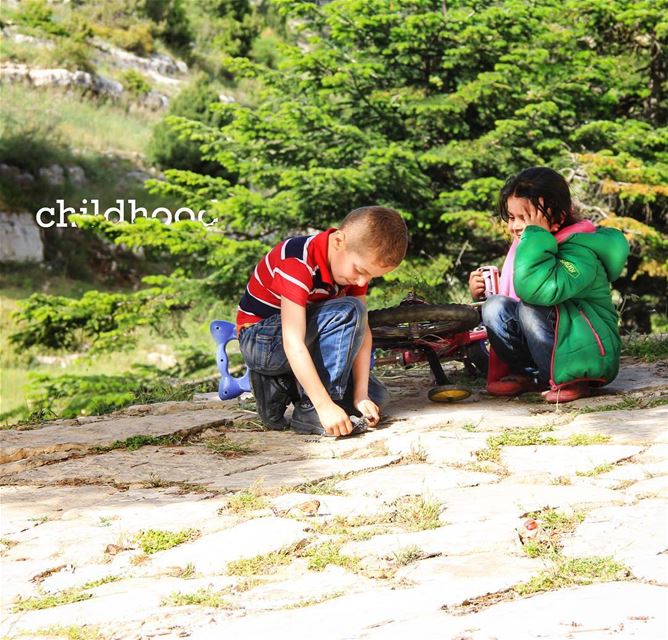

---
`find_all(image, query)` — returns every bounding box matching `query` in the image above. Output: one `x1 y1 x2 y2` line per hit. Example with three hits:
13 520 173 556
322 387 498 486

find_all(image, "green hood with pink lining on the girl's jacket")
555 220 629 282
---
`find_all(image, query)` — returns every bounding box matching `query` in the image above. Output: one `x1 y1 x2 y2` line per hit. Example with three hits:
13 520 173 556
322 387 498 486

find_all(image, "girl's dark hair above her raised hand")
499 167 576 228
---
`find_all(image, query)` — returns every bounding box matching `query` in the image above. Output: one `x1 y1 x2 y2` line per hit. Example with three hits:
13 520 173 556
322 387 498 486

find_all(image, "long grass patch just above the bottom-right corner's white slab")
513 556 632 596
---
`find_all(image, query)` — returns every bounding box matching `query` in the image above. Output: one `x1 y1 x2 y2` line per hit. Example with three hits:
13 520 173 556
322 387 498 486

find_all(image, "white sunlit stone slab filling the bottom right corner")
358 582 668 640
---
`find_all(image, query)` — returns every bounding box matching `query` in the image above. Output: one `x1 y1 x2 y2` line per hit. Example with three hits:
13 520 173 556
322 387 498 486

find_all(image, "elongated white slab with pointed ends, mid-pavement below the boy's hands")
336 464 498 503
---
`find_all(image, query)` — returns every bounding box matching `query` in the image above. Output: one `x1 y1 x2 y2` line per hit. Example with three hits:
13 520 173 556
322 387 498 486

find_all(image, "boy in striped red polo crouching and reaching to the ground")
237 206 408 436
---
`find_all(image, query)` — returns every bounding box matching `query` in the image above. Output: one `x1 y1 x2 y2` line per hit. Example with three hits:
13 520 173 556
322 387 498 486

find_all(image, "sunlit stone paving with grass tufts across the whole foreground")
0 361 668 640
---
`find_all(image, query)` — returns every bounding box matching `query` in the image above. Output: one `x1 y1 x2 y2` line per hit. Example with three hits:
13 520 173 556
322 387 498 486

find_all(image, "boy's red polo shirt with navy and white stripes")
237 229 368 330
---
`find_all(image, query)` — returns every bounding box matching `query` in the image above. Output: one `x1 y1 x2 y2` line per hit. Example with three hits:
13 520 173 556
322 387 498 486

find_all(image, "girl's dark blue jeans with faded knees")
482 295 556 385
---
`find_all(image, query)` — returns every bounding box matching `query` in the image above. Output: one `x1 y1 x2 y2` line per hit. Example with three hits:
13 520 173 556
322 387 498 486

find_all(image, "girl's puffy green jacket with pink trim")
513 222 629 388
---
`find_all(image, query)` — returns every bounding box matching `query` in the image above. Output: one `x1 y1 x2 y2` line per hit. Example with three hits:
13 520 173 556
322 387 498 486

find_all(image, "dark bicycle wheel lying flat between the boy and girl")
369 304 480 340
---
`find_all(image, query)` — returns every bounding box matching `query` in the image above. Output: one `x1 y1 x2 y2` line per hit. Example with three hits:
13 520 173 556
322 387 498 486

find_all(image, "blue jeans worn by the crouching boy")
239 296 389 411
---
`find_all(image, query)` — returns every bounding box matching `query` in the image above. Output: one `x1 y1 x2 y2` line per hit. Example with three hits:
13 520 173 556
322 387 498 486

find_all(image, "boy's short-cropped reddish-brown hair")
339 206 408 267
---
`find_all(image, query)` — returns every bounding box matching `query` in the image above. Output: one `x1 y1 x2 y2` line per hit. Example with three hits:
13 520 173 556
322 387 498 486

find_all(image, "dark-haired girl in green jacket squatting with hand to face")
469 167 629 403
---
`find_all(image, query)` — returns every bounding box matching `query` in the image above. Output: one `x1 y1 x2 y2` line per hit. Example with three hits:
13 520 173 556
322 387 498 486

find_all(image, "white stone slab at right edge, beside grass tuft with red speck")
562 500 668 568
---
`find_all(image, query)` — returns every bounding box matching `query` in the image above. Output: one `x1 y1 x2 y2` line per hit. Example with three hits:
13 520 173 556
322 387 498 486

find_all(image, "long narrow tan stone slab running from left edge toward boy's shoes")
0 408 239 463
